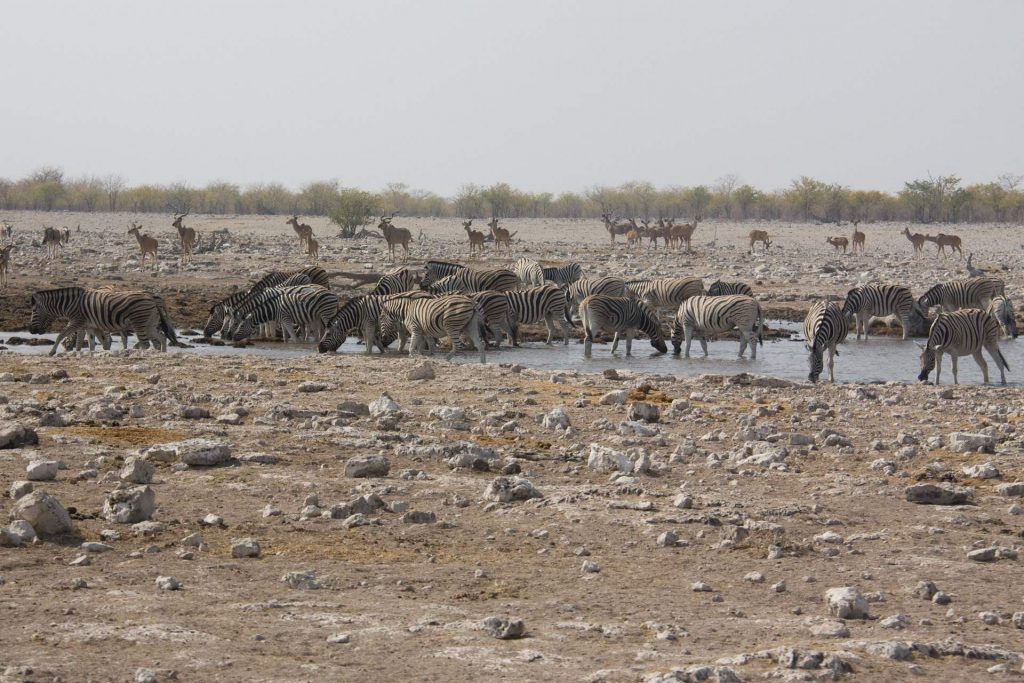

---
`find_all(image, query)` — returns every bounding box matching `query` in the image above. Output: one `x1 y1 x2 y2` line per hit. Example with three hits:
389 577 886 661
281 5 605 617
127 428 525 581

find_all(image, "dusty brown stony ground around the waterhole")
0 214 1024 681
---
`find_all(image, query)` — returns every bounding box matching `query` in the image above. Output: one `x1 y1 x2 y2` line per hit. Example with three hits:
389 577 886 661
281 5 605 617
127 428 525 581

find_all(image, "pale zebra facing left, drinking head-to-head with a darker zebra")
672 294 765 360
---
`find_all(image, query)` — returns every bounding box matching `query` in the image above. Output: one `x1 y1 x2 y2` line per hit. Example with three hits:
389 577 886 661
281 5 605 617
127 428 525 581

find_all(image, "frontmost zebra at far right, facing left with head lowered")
918 308 1010 385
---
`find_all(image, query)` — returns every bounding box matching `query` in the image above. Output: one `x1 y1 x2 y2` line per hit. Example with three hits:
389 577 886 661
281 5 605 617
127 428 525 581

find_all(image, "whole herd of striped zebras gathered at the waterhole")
22 258 1017 383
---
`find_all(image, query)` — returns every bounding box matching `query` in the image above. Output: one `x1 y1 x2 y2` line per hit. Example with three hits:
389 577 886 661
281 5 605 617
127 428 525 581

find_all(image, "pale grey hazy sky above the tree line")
0 0 1024 195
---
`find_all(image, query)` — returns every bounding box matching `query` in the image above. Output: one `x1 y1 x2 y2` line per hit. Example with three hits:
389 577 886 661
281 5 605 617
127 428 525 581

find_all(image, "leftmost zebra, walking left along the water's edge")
29 287 174 355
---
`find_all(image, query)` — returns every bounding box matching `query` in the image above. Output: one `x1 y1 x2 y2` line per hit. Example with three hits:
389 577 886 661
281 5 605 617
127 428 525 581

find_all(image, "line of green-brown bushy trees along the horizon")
0 167 1024 224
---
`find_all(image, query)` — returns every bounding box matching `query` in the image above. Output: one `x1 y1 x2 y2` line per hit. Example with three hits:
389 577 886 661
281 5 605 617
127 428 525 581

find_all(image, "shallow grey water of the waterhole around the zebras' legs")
0 322 1024 386
